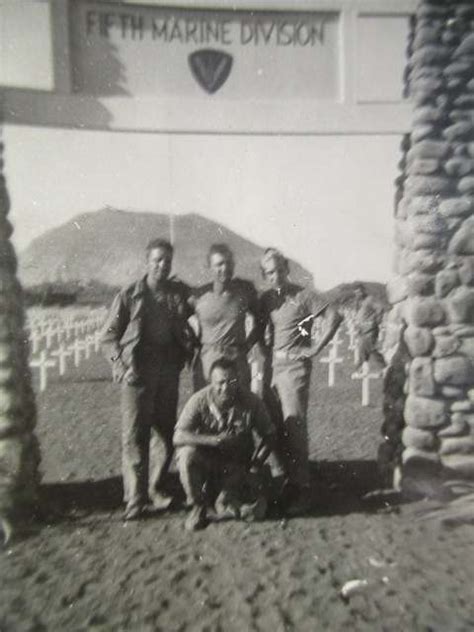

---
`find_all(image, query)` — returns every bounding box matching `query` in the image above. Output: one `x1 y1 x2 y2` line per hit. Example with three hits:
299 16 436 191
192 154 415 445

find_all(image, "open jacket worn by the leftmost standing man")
102 277 193 382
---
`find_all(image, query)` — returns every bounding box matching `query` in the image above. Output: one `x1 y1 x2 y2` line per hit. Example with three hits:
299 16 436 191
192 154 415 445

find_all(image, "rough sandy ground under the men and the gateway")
0 334 474 632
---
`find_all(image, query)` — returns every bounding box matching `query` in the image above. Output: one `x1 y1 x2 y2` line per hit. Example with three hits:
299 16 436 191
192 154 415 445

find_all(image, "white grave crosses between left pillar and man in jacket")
29 309 105 392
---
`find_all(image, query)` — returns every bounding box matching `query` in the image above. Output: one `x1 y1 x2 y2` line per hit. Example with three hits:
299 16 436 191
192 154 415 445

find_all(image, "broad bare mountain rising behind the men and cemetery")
19 207 313 287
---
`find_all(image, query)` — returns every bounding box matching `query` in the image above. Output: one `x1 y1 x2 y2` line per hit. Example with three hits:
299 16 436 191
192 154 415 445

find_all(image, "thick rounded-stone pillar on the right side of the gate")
385 0 474 492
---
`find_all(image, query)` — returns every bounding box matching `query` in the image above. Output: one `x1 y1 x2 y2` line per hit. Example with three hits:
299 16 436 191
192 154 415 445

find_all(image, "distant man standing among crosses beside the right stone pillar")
353 283 386 377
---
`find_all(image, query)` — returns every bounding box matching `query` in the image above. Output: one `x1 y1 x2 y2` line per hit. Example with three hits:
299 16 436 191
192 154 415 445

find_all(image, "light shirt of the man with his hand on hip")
259 284 328 352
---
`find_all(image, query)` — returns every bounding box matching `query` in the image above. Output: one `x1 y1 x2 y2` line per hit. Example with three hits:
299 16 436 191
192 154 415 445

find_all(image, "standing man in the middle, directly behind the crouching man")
193 244 258 391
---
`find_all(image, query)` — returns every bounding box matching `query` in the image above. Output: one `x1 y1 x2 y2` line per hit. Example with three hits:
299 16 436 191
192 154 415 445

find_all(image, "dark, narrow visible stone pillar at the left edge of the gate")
0 111 40 540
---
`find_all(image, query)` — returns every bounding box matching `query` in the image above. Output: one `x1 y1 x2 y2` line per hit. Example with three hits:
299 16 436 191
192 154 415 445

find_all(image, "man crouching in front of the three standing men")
174 358 275 530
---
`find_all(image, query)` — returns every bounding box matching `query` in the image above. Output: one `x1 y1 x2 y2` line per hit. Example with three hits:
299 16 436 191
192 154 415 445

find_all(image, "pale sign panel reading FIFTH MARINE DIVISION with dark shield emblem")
71 2 339 100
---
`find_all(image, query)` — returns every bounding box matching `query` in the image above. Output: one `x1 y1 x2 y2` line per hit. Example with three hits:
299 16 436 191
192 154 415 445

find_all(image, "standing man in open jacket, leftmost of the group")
102 239 191 520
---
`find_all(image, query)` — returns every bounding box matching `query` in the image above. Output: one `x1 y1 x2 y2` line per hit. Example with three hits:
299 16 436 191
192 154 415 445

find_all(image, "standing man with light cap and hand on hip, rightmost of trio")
259 248 342 515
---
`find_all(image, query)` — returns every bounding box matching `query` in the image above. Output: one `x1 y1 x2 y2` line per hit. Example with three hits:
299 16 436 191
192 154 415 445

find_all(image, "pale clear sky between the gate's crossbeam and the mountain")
4 125 400 289
